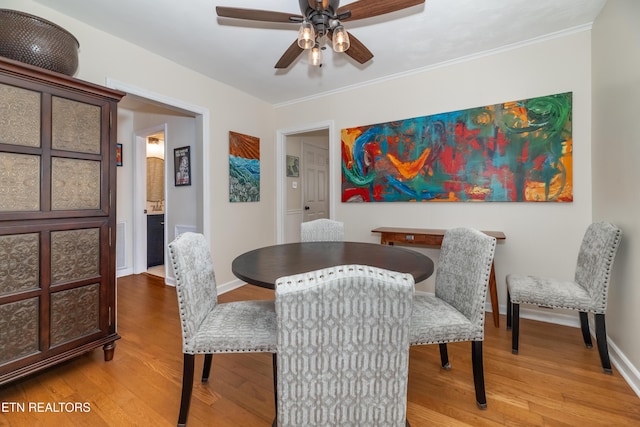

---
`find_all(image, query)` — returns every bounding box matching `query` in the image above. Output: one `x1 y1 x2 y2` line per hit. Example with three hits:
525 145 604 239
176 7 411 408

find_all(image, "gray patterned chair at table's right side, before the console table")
411 228 496 409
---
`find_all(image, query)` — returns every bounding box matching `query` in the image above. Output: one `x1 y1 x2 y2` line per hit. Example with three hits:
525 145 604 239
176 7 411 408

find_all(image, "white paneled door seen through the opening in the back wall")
302 144 329 222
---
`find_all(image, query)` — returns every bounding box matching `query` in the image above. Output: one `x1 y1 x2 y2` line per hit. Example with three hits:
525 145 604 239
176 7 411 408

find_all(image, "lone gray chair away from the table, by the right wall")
507 222 622 373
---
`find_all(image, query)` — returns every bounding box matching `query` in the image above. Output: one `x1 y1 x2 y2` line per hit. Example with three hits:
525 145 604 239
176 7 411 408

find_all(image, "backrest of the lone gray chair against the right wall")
575 221 622 313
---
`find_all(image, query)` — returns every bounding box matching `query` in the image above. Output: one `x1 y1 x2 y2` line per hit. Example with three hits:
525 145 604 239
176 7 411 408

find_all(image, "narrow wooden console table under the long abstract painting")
371 227 506 328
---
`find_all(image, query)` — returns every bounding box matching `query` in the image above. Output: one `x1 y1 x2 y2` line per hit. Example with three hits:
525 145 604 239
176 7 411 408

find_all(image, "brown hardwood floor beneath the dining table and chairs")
0 274 640 427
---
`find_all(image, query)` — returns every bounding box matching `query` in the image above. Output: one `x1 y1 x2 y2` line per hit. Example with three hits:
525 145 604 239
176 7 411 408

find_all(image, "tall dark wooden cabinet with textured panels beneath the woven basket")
0 57 124 384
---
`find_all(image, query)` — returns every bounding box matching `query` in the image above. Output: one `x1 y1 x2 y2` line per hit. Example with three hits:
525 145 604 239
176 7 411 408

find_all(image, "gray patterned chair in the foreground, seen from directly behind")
276 265 414 427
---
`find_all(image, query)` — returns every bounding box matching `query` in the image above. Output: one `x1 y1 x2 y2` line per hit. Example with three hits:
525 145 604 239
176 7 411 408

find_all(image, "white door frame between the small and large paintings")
276 120 340 243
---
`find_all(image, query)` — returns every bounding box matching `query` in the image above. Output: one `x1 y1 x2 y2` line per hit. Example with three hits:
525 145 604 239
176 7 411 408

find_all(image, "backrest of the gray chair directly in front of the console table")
435 227 496 337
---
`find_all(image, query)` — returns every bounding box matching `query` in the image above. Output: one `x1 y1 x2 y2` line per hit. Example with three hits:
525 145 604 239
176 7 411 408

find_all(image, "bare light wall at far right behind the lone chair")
592 0 640 392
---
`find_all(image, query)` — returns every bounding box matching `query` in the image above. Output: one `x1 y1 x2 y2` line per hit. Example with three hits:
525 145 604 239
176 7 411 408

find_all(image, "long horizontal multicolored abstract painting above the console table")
342 92 573 202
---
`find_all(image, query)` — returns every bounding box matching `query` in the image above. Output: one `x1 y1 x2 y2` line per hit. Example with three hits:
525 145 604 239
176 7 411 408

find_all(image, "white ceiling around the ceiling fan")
36 0 606 104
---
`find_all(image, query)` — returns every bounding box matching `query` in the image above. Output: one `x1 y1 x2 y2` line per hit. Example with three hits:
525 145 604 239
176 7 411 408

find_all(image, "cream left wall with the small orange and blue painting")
7 0 275 283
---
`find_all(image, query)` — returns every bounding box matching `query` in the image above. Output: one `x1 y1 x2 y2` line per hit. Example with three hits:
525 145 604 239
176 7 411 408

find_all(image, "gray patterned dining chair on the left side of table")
169 232 276 426
